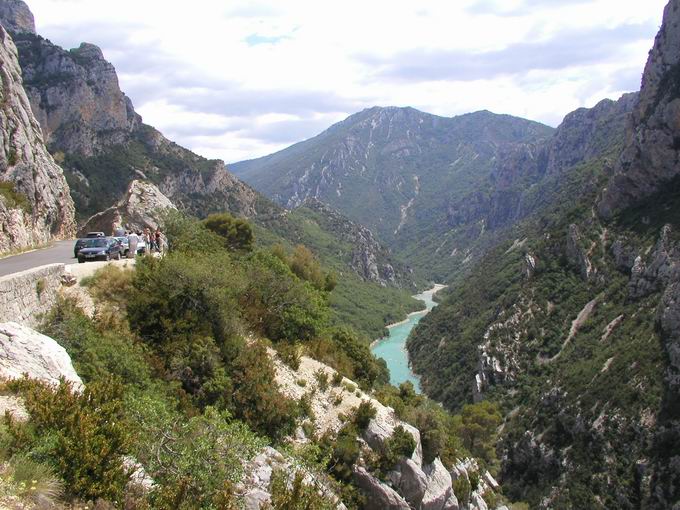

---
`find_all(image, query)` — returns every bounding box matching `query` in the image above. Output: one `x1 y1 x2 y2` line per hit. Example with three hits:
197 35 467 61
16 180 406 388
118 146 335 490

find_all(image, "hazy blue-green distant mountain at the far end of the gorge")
231 100 636 280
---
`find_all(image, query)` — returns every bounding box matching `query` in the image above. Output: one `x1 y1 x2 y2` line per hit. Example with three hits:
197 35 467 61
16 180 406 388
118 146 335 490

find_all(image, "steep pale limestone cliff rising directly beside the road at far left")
0 27 75 252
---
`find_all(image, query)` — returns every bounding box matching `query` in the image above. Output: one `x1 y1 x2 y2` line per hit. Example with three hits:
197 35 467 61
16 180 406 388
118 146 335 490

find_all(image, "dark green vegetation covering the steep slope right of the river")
408 152 679 508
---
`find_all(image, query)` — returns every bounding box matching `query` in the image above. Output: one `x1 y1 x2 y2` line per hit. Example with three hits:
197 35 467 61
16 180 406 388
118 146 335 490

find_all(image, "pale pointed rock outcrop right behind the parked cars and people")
79 180 177 236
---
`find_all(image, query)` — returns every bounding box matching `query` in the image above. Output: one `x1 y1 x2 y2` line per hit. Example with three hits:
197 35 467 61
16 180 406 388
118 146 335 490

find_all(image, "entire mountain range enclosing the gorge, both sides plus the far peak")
0 0 680 509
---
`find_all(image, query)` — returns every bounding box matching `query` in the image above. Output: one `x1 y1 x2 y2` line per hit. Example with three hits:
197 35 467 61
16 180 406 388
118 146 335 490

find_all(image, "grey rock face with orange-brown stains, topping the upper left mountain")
15 33 141 156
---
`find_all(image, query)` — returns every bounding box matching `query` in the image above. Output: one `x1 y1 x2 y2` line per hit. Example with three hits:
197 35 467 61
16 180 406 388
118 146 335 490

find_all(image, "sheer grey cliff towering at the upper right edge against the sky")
598 0 680 218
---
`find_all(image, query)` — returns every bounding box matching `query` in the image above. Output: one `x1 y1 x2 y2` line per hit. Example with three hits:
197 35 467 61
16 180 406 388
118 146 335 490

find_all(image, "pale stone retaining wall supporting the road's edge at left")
0 264 65 327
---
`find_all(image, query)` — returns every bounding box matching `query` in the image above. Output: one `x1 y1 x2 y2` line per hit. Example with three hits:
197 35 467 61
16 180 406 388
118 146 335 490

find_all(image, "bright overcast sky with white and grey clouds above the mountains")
26 0 666 162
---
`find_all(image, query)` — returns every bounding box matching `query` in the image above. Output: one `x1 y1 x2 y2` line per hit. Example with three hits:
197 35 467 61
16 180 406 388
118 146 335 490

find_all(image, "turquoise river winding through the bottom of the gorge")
371 285 445 393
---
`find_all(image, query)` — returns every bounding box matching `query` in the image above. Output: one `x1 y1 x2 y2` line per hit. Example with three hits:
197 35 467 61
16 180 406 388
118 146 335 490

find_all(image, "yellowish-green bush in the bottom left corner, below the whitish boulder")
8 379 129 501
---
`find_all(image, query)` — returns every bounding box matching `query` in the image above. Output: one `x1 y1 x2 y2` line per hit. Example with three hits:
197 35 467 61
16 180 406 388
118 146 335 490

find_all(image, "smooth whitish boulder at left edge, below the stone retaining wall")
0 322 83 390
